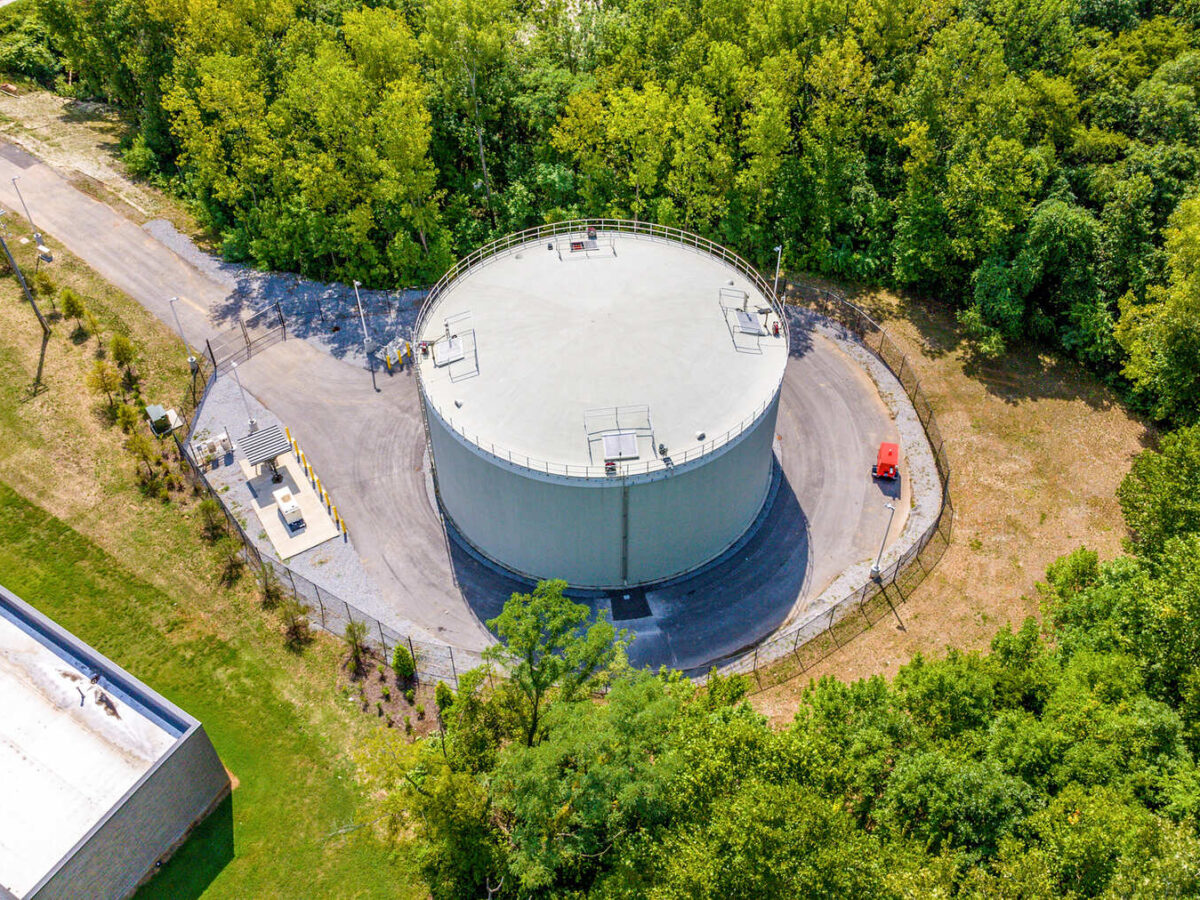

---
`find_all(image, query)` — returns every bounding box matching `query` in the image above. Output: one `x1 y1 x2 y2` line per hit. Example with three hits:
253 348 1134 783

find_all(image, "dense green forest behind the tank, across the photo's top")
14 0 1200 418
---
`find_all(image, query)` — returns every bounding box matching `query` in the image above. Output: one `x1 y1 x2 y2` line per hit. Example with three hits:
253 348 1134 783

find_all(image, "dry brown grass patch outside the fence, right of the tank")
752 292 1154 721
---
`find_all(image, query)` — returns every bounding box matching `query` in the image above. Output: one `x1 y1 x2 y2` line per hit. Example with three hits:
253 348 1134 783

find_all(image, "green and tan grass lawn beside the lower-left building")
0 229 427 899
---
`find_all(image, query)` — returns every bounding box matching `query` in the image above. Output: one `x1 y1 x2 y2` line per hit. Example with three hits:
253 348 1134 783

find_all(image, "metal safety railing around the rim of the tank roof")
413 218 791 478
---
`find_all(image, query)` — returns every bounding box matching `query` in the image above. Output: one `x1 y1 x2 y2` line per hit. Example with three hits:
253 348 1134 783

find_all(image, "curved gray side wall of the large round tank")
428 394 779 587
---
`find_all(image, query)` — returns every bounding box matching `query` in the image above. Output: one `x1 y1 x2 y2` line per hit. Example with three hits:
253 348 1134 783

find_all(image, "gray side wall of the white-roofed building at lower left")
28 726 229 900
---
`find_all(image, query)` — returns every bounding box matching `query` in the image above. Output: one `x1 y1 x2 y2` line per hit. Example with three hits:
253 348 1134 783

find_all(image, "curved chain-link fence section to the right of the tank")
720 284 954 690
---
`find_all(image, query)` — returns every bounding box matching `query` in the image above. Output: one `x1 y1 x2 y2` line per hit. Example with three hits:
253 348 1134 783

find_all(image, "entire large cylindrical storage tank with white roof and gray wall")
415 221 787 588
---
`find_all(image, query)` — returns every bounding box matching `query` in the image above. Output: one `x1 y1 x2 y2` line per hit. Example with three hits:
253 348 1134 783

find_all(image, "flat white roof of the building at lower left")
0 616 179 898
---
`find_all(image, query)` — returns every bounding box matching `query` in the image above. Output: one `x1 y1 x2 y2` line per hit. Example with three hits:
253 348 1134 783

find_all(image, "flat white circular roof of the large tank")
416 232 787 475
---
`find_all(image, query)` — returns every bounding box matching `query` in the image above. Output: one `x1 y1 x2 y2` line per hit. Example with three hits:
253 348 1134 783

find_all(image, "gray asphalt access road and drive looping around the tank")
0 143 908 668
